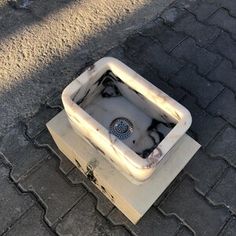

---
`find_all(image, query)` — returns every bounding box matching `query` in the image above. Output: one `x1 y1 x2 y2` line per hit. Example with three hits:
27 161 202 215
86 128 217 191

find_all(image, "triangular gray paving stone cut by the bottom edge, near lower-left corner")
4 206 55 236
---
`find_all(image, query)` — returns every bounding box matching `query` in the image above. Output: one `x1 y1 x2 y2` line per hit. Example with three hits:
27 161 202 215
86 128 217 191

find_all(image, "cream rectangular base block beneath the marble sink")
47 111 200 224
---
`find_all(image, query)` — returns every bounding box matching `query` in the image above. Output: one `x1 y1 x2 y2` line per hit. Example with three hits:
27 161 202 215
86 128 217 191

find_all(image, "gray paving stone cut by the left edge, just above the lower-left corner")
0 163 34 234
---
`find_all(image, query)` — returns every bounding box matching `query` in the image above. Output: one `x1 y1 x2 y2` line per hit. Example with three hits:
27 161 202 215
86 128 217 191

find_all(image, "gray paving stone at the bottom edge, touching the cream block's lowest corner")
108 207 181 236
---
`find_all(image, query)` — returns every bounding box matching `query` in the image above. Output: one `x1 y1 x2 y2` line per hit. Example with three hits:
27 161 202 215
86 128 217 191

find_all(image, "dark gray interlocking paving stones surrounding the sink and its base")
0 0 236 236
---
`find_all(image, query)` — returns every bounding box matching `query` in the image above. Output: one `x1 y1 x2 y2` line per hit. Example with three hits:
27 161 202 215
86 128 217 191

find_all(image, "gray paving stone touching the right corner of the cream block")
184 150 228 195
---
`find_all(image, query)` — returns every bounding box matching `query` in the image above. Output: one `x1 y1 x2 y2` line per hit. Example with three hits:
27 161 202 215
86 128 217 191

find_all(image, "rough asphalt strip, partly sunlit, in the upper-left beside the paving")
0 0 173 134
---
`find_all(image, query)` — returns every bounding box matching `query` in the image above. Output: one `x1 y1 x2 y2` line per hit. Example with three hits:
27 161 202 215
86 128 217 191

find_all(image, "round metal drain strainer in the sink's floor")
109 117 133 140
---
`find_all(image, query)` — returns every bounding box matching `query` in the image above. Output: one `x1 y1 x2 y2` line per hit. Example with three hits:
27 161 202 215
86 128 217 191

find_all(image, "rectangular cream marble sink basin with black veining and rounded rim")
62 57 192 184
